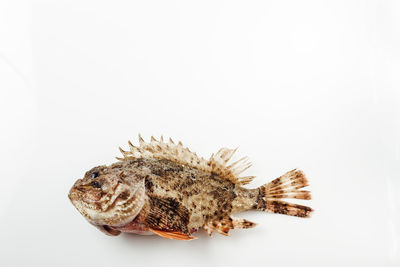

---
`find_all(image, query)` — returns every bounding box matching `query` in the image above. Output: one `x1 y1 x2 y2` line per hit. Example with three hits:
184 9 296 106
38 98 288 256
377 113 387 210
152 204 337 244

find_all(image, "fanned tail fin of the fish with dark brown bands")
256 169 313 217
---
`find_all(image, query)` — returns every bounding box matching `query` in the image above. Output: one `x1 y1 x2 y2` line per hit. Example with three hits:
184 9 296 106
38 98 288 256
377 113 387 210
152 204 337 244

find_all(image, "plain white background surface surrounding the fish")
0 0 400 267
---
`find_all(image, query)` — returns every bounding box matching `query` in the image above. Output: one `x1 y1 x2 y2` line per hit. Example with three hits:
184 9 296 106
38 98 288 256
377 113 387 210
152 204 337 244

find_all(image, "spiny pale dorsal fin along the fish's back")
117 134 254 185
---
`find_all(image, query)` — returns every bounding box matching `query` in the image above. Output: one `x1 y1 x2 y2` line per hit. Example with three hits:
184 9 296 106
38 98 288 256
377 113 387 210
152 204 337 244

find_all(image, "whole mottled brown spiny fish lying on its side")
68 134 313 240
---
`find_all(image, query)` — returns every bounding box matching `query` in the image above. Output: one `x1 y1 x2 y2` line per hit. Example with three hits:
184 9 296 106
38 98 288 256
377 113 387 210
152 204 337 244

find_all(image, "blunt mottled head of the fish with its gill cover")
68 163 145 234
